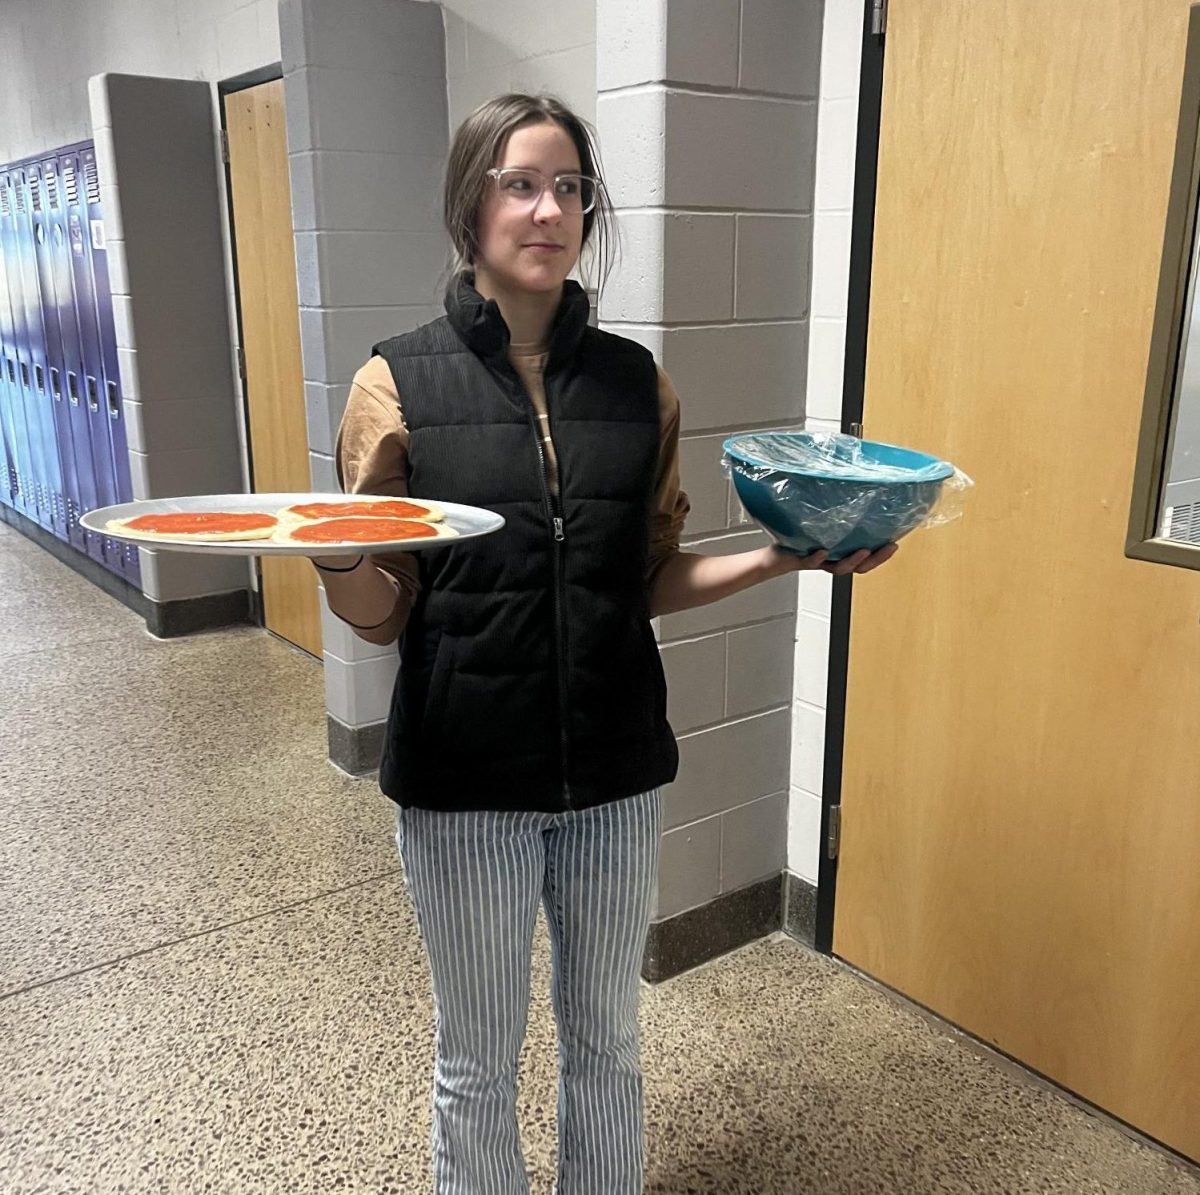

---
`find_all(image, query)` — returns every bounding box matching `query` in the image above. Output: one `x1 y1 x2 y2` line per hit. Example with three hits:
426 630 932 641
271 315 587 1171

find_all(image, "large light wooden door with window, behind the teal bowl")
834 0 1200 1158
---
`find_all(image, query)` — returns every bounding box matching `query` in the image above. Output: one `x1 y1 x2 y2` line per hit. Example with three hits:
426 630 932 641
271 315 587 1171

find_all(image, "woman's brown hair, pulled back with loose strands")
443 94 616 293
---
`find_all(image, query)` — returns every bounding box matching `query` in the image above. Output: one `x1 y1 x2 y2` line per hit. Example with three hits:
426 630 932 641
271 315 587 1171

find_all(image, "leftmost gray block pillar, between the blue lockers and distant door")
89 74 250 602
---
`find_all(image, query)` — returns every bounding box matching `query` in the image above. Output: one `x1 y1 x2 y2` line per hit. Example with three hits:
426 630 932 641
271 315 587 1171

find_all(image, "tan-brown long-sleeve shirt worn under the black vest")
335 344 689 638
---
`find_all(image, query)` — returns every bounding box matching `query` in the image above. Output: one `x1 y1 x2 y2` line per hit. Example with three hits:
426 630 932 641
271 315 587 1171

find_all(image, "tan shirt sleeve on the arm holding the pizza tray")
335 356 420 636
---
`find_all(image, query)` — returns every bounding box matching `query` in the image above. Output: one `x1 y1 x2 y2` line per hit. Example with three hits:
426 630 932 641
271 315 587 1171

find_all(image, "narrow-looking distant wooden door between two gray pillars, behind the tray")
224 79 322 659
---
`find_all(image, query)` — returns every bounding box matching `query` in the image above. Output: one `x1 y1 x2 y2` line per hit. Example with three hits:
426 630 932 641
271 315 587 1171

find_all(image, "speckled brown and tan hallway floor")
7 526 1200 1195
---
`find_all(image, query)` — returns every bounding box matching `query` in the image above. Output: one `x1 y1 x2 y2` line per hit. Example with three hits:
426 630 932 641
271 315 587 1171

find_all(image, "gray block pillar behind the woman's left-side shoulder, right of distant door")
280 0 449 744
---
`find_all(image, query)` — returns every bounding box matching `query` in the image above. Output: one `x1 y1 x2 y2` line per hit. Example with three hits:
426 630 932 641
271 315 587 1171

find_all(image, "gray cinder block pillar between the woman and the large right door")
596 0 822 923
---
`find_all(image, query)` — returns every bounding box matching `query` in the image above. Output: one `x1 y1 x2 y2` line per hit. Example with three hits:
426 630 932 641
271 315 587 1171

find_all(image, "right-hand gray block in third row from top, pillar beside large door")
736 215 812 319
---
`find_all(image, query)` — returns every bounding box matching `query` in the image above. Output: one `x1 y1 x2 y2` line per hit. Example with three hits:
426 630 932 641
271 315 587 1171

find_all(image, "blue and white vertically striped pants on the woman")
396 792 660 1195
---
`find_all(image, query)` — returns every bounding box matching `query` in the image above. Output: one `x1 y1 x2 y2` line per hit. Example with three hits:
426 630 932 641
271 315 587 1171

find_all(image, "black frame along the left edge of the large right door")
814 0 887 955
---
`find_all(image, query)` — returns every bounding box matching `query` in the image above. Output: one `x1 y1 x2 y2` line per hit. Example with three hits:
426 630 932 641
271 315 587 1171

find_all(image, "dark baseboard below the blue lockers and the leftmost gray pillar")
0 505 256 639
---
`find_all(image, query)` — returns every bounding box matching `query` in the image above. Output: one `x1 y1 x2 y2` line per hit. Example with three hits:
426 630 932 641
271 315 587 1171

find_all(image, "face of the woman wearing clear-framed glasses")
474 122 583 293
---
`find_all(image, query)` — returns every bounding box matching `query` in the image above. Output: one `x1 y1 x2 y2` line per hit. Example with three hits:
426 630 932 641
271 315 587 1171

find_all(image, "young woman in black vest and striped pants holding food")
317 95 894 1195
